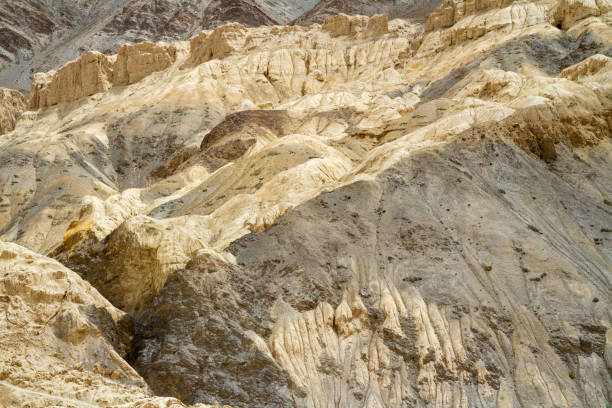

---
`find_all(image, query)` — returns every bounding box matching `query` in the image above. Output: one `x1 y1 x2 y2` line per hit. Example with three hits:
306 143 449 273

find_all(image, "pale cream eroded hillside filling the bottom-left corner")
0 242 148 406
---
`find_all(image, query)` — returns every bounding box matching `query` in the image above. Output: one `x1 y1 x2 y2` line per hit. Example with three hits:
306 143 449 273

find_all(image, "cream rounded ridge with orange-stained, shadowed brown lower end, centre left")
57 135 349 315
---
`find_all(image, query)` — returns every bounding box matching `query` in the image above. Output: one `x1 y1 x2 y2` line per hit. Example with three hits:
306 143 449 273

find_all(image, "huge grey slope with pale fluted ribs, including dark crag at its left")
136 130 610 407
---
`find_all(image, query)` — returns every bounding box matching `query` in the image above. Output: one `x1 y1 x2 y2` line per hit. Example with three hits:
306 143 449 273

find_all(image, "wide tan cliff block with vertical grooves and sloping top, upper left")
28 51 113 109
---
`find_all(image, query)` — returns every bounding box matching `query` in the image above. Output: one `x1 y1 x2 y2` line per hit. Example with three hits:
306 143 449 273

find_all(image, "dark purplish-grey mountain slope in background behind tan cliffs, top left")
0 0 315 90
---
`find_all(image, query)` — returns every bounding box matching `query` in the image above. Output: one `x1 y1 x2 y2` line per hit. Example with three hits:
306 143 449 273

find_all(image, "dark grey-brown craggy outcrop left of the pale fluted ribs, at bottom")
135 251 293 407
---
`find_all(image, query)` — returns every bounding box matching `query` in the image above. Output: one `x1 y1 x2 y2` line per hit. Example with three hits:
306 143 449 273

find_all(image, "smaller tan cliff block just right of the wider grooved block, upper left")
113 41 177 86
